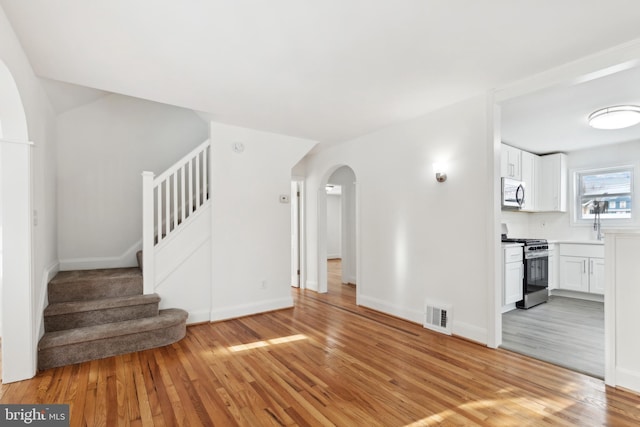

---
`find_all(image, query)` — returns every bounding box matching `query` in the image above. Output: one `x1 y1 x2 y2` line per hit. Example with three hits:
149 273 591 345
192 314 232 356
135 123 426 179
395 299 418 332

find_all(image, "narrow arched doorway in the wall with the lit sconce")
317 165 360 295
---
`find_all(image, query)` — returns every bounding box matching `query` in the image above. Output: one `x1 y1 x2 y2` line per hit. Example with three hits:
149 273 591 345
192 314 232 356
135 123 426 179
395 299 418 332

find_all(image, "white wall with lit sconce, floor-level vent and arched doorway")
306 96 497 342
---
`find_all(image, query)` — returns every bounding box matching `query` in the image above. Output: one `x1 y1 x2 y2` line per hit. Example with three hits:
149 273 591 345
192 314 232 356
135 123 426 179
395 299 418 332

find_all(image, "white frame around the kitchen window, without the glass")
571 165 640 228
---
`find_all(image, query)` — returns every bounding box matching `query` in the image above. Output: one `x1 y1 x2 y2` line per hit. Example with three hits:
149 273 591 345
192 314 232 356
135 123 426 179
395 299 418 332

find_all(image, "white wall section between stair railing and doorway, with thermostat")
211 123 315 320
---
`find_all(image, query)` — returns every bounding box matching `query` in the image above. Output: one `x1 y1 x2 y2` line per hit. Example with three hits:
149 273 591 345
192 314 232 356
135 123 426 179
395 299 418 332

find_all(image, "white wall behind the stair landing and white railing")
57 94 208 269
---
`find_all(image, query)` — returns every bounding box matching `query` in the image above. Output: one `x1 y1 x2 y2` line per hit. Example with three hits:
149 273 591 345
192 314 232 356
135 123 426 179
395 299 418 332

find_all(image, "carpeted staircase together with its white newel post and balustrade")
38 140 211 370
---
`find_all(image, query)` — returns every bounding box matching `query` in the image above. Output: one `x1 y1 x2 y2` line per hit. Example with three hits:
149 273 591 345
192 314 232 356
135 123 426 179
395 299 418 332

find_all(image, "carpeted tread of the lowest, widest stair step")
38 308 189 351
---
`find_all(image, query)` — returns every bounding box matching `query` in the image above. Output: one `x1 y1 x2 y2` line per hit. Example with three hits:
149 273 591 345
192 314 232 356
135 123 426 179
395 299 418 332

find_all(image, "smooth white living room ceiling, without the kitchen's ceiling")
0 0 640 151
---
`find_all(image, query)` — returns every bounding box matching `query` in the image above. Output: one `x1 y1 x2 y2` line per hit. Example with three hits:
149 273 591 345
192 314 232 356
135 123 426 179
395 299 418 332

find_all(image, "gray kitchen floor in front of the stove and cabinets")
501 296 604 378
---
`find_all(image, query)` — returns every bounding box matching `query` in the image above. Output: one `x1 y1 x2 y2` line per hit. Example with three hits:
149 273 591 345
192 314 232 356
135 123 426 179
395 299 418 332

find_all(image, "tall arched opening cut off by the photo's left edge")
0 60 37 383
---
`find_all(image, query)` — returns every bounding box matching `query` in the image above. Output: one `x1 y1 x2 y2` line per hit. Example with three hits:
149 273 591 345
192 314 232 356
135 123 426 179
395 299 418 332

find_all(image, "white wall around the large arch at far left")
0 8 57 382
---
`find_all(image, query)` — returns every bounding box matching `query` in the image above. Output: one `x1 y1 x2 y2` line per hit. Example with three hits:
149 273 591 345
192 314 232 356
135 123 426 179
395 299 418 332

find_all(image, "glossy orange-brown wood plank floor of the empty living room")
0 265 640 427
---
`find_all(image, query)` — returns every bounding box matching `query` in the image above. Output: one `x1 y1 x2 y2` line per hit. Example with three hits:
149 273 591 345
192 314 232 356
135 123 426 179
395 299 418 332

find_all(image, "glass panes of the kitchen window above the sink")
576 167 633 220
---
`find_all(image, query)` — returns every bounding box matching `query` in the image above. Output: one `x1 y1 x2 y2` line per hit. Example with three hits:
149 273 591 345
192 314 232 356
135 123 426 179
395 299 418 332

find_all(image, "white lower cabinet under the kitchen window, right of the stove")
558 244 604 294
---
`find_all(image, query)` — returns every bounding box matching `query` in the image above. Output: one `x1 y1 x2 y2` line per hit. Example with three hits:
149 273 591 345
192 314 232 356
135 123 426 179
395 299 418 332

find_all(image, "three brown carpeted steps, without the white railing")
38 268 188 370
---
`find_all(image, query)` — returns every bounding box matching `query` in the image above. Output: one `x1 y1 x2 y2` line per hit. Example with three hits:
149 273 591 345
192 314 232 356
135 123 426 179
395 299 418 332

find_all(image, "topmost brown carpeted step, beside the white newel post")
48 267 143 304
